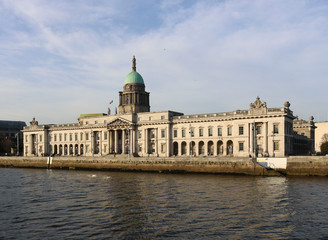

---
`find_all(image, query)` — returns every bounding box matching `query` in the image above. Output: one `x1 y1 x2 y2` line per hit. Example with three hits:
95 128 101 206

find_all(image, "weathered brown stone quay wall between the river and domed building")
0 156 328 176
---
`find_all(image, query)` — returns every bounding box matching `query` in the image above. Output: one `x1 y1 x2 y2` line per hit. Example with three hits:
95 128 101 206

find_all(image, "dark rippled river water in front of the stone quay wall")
0 168 328 239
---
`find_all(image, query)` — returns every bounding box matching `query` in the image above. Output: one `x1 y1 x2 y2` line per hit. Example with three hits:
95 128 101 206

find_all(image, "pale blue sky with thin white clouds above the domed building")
0 0 328 124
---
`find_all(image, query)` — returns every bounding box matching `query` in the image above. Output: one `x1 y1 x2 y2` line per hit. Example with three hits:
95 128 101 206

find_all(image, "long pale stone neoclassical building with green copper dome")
23 57 294 157
